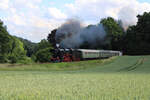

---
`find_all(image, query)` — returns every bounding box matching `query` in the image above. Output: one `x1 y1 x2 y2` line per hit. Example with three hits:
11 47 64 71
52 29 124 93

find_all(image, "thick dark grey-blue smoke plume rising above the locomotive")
56 19 106 48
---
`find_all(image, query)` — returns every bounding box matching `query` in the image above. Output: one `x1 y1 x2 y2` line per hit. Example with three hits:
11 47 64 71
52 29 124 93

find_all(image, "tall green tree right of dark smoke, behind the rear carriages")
100 17 124 50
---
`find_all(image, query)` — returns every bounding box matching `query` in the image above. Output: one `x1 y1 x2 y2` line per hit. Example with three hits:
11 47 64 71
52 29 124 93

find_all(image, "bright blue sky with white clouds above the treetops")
0 0 150 42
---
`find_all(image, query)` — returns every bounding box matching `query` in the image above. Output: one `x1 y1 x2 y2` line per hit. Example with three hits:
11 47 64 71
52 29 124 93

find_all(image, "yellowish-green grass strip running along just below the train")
0 57 116 71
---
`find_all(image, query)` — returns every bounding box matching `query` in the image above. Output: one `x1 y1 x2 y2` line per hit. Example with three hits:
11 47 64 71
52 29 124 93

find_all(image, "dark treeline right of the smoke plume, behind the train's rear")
101 12 150 55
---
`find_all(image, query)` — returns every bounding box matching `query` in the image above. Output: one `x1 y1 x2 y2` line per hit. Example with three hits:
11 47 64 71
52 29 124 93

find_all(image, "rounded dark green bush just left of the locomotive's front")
36 48 52 63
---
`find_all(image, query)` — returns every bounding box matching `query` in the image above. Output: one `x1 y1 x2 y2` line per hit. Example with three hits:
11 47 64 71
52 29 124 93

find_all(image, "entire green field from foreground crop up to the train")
0 56 150 100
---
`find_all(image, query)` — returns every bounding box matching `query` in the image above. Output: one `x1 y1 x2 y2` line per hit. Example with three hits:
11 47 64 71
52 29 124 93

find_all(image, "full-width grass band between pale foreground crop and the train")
0 56 150 73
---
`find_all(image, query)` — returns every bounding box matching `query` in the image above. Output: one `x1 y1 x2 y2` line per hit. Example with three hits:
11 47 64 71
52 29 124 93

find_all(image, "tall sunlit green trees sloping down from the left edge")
0 21 30 63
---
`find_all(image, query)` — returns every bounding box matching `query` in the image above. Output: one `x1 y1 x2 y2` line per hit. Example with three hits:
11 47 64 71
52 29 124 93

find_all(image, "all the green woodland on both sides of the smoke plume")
0 12 150 64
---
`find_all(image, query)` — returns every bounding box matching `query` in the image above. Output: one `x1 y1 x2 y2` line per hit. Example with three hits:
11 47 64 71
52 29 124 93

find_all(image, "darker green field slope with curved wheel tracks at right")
82 56 150 73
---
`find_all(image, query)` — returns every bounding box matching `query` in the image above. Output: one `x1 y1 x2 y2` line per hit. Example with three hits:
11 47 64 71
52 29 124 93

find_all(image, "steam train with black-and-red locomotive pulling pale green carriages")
51 49 122 62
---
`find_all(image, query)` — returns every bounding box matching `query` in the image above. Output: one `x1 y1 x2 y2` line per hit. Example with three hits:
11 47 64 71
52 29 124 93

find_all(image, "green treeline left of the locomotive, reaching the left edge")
0 20 52 64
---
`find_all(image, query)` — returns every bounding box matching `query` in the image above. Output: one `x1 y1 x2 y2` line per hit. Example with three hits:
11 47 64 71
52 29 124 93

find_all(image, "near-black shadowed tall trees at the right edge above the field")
126 12 150 54
